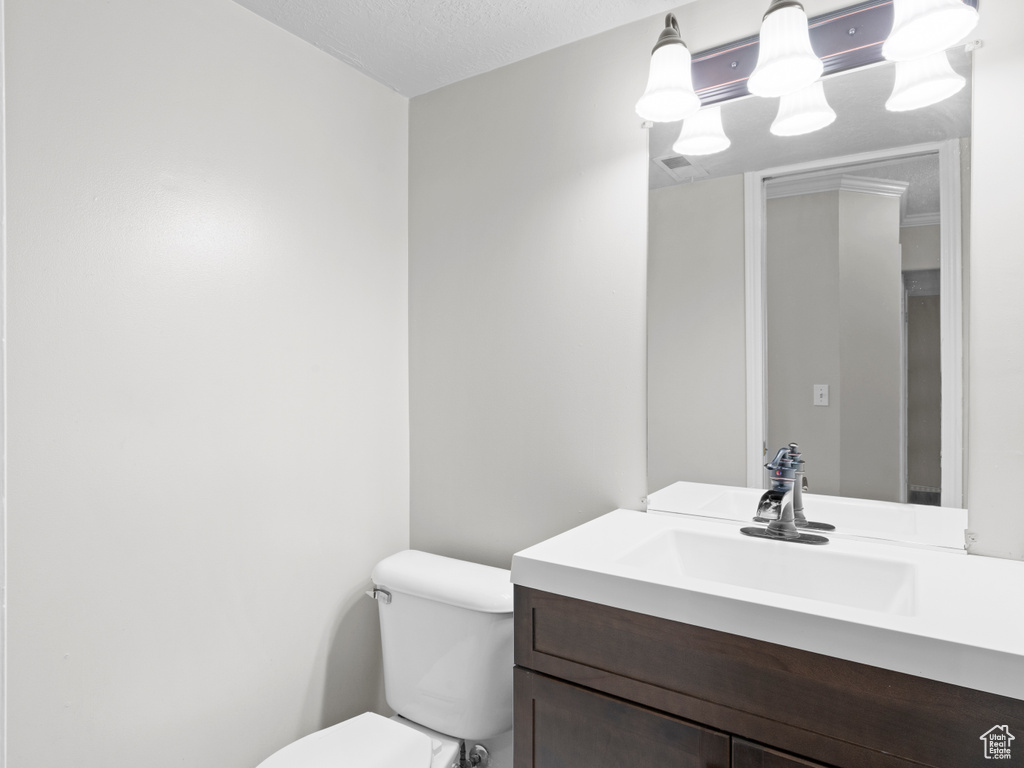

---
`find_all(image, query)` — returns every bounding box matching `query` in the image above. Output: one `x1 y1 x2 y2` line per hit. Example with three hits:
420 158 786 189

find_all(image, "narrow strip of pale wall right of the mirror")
968 0 1024 559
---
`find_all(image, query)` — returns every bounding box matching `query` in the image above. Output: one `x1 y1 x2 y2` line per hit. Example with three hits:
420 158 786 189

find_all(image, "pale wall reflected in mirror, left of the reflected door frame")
647 175 746 490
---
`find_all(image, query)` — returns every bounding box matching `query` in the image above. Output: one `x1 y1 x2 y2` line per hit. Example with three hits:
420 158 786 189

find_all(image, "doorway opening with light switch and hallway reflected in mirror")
764 153 954 505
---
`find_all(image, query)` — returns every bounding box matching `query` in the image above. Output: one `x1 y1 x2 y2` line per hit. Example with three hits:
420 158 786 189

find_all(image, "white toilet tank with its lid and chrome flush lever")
373 550 512 739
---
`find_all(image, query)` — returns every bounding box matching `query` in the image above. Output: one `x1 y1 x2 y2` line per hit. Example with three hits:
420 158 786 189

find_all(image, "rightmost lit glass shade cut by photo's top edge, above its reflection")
882 0 978 61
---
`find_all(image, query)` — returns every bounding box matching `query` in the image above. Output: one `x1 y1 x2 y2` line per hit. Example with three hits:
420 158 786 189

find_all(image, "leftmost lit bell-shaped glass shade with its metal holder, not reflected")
637 13 700 123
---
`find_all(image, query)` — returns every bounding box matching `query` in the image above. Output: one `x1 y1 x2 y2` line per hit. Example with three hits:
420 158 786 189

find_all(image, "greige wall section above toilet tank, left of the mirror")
410 20 649 567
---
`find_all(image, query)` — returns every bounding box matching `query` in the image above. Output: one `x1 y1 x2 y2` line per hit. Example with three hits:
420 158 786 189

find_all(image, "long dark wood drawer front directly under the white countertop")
515 587 1024 768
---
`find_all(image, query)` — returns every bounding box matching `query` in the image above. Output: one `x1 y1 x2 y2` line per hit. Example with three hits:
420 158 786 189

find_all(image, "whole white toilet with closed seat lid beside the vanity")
258 550 512 768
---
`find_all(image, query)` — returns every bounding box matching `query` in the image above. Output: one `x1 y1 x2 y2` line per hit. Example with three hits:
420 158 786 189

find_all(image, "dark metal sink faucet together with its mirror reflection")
740 442 836 544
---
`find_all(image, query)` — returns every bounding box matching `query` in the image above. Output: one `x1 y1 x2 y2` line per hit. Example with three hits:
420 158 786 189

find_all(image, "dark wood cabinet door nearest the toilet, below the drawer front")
514 667 729 768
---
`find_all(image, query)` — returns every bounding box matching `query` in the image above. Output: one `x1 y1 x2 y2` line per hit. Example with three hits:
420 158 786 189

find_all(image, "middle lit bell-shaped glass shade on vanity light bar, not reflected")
746 0 824 96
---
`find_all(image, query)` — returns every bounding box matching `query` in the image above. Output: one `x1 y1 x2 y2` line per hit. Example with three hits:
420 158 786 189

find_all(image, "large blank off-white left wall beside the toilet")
5 0 409 768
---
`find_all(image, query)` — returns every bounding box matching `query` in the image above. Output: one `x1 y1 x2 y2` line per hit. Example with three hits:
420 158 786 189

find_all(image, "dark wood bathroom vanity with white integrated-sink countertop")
512 487 1024 768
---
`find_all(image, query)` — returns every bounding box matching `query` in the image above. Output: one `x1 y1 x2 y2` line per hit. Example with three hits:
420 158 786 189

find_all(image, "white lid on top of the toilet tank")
373 549 512 613
